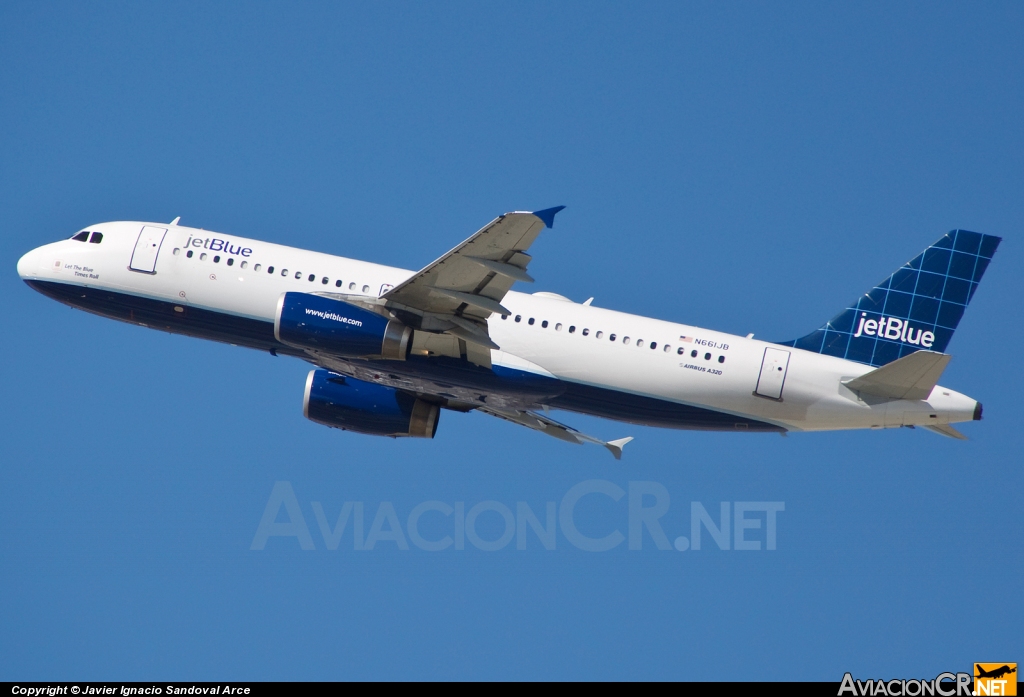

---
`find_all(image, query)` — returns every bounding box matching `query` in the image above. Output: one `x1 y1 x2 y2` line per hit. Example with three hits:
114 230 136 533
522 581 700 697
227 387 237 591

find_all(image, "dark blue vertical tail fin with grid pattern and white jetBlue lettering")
779 230 1001 367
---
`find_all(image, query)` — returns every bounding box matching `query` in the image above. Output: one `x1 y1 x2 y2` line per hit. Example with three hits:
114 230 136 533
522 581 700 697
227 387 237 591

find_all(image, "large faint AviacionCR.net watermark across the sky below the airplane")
250 479 785 552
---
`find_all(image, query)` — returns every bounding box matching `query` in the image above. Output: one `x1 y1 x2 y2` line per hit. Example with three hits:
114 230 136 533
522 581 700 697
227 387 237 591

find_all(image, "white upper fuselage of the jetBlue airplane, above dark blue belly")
18 222 977 431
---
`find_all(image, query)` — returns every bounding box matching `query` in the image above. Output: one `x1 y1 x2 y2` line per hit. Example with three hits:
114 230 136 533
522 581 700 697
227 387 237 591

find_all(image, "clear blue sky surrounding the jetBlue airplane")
0 2 1024 681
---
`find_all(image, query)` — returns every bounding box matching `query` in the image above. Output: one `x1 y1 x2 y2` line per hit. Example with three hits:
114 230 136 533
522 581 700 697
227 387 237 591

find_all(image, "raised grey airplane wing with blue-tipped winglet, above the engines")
381 206 565 349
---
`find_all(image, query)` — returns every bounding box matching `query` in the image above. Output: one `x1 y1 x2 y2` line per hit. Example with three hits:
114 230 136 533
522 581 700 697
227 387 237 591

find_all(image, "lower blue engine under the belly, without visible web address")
302 369 440 438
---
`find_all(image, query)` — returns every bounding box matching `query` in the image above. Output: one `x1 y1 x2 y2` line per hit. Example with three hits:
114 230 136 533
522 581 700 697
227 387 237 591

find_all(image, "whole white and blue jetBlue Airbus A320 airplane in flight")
17 206 1000 459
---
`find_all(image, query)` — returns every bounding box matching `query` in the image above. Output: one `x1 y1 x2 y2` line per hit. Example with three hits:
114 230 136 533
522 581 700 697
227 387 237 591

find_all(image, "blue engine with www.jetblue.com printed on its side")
273 293 413 360
